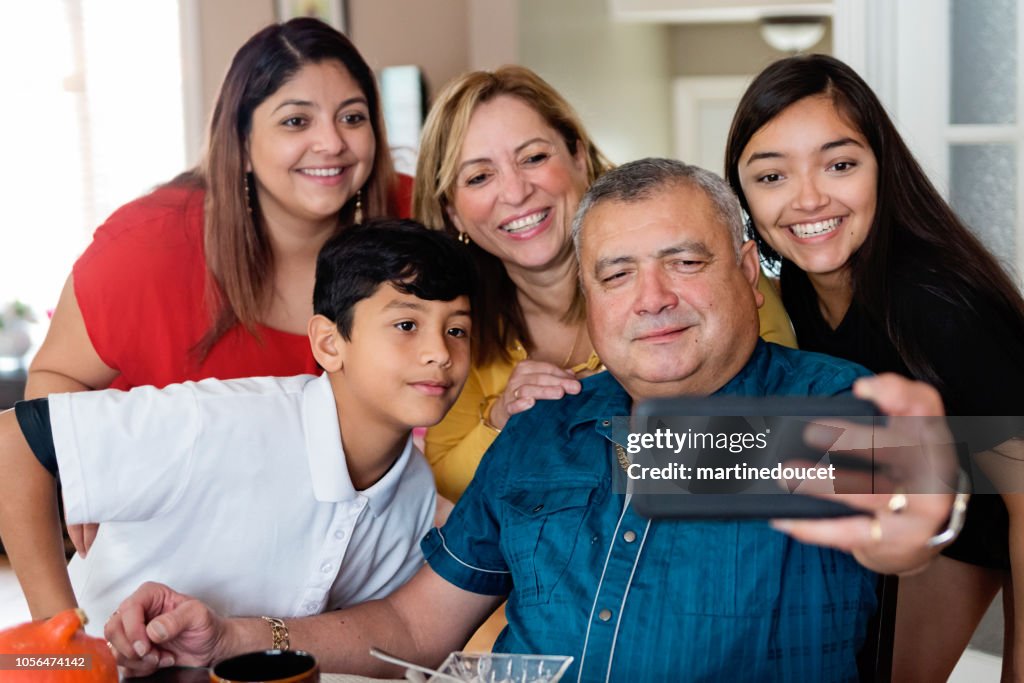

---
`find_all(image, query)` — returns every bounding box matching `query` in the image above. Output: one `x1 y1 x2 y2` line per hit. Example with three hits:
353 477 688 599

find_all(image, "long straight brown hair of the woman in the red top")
190 17 396 358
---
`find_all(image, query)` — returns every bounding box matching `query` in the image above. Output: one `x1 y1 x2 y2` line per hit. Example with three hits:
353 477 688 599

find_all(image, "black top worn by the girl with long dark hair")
782 268 1024 570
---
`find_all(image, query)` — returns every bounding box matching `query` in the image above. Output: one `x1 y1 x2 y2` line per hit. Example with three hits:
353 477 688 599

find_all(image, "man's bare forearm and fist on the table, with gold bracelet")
104 565 502 677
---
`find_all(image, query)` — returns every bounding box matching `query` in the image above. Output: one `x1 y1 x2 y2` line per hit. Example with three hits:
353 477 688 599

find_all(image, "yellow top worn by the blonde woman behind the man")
426 272 797 502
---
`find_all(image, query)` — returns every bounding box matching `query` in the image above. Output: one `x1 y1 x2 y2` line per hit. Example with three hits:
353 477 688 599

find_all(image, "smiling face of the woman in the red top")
247 60 376 236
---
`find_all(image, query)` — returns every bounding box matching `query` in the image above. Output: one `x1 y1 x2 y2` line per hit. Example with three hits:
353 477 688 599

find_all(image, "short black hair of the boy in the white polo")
313 218 476 340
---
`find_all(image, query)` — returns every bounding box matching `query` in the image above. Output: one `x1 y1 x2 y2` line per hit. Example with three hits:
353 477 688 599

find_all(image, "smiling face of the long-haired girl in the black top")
738 95 879 282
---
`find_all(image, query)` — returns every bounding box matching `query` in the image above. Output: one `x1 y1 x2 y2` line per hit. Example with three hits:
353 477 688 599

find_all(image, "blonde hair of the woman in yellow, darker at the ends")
413 66 612 365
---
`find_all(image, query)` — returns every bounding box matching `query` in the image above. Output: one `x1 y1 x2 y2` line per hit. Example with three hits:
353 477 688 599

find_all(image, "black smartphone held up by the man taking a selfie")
615 395 885 519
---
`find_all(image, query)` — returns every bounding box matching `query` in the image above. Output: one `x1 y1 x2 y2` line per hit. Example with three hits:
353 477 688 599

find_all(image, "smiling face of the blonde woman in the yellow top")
449 95 587 270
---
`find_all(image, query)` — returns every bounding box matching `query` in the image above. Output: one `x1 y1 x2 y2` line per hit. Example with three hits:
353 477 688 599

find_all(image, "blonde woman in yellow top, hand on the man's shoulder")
413 67 795 500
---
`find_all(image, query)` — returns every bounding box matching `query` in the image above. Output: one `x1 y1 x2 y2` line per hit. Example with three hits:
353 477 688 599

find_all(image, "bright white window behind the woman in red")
0 0 185 336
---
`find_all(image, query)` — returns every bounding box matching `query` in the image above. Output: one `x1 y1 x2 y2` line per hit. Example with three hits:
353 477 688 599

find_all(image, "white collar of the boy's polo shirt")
302 373 414 516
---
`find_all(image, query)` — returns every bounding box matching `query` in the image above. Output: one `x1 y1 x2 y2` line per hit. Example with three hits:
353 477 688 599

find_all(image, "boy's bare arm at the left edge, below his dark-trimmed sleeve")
0 411 78 618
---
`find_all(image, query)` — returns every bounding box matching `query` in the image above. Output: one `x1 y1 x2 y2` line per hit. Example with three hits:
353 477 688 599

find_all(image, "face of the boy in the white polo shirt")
323 284 470 432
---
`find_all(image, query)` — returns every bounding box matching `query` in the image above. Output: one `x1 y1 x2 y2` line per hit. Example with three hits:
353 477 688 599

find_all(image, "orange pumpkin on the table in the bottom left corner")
0 607 118 683
